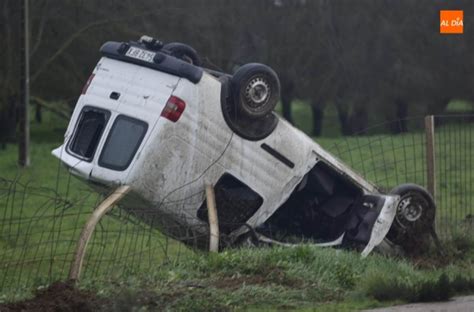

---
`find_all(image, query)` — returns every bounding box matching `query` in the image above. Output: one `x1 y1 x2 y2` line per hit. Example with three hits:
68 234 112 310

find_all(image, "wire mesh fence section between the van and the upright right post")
328 118 426 192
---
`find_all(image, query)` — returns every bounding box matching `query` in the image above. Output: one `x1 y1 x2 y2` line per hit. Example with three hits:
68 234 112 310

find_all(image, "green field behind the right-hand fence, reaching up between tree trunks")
277 100 474 229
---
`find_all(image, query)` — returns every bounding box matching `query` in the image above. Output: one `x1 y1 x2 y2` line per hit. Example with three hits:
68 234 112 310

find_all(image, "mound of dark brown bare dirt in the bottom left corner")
0 282 103 312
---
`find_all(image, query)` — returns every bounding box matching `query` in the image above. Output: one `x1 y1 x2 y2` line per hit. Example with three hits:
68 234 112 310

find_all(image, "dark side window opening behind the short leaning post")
197 173 263 234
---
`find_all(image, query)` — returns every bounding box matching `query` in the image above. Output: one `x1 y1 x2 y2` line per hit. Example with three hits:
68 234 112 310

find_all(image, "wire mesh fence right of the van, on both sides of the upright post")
328 115 474 236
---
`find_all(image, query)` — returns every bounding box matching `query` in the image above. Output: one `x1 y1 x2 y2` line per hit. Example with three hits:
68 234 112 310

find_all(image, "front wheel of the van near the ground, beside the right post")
387 184 436 253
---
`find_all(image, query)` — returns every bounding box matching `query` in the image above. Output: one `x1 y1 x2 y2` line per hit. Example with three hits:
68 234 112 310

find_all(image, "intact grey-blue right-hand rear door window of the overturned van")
99 115 148 171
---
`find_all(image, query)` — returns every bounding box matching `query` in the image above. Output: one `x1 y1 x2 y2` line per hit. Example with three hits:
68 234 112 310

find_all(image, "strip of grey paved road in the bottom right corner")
367 296 474 312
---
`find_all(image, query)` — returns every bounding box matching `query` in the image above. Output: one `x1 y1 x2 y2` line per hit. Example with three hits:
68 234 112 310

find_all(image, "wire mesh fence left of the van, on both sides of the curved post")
0 169 190 299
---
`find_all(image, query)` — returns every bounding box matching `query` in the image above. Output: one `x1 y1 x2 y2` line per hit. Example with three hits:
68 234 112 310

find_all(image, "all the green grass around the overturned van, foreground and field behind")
0 108 474 310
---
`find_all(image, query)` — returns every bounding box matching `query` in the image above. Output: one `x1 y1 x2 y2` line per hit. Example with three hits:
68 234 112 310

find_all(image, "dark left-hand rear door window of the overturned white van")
69 106 110 162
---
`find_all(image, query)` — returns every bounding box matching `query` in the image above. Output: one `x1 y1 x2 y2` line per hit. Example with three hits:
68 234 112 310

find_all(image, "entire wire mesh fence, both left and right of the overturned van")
0 116 474 299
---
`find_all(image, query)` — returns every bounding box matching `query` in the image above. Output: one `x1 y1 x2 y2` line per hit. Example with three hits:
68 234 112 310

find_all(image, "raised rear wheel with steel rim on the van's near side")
231 63 280 118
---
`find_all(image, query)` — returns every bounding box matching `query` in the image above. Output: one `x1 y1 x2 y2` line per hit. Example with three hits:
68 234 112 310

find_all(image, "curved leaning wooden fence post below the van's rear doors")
69 185 130 280
